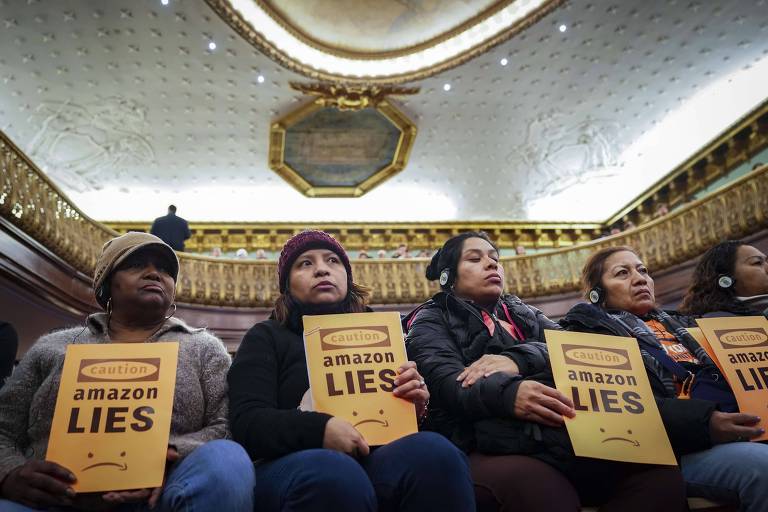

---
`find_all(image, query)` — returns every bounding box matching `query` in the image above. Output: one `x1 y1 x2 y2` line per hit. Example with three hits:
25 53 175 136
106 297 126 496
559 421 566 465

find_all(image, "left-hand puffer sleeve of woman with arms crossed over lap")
406 308 521 420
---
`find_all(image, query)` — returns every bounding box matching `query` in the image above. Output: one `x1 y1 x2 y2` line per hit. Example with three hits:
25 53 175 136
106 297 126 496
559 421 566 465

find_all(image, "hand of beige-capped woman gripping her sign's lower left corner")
0 460 76 508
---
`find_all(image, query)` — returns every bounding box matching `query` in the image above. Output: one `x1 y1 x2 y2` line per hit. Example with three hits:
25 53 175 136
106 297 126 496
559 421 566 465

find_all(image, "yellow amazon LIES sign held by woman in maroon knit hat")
304 312 417 445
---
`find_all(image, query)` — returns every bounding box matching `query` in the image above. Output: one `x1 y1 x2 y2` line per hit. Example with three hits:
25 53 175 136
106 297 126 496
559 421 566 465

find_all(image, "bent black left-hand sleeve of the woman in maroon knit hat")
227 323 331 459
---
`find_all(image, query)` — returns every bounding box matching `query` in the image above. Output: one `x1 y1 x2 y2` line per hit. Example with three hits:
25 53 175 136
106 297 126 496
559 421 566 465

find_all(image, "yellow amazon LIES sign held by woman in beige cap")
46 342 179 492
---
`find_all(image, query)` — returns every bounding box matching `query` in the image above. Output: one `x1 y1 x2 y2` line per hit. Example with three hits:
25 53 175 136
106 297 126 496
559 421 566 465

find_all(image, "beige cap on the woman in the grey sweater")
93 231 179 308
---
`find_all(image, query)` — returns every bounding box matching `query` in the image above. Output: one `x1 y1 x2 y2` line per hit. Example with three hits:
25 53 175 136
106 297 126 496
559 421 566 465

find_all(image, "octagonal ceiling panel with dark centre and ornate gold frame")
269 90 418 197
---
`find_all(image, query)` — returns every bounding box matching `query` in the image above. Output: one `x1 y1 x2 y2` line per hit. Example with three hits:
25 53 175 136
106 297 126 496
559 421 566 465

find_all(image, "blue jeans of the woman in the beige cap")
0 439 254 512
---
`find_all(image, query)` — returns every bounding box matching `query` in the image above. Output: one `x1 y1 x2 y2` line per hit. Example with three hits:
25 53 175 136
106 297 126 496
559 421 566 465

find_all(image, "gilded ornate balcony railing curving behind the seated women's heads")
0 133 768 307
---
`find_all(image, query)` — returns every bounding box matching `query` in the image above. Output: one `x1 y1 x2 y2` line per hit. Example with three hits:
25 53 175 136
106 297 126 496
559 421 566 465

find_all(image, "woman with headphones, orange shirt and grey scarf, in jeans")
560 247 768 511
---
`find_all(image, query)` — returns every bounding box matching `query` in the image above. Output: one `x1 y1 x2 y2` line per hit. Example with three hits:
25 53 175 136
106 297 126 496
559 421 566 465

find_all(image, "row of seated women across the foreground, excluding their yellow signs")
0 231 768 511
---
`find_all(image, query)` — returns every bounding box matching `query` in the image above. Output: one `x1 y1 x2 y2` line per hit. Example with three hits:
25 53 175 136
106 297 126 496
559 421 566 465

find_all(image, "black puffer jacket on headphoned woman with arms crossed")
404 292 572 462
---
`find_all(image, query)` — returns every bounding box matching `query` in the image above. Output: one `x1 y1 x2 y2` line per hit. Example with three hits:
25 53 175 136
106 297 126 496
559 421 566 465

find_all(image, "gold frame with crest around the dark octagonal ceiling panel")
269 93 418 197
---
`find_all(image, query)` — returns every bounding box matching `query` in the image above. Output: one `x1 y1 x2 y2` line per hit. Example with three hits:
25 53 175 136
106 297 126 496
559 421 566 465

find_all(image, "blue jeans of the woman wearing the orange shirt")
680 443 768 512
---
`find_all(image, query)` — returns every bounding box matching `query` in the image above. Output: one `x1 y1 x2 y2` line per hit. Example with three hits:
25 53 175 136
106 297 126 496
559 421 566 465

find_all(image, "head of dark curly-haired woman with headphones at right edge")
680 240 768 317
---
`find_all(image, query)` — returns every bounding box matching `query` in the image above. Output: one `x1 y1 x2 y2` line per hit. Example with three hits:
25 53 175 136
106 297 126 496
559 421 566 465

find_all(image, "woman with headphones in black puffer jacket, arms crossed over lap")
405 232 685 512
